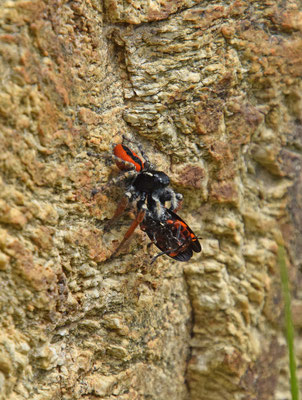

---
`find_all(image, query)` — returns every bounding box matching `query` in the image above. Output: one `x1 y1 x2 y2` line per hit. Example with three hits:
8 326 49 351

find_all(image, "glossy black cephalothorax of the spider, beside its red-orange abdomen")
133 170 170 193
